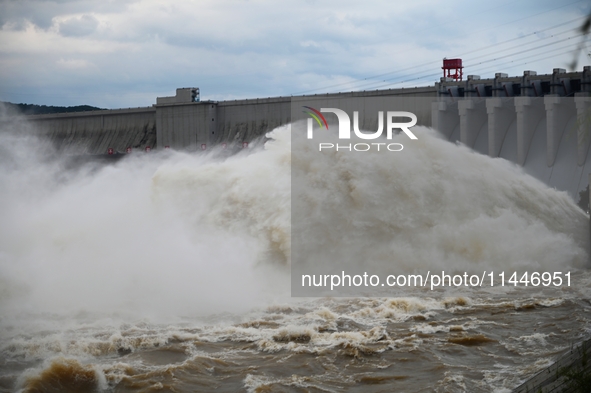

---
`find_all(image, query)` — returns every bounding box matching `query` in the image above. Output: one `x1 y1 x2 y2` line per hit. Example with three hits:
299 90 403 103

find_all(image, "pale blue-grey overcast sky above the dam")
0 0 591 108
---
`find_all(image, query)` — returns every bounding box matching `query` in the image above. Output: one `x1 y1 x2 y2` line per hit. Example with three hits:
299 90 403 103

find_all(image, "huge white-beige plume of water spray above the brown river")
0 113 589 324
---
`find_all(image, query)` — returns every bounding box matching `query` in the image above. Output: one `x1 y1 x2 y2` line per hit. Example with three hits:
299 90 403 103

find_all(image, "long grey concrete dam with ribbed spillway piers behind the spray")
16 66 591 200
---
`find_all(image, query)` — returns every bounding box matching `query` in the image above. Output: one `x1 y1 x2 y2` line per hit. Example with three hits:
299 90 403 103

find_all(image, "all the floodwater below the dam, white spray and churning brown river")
0 117 591 392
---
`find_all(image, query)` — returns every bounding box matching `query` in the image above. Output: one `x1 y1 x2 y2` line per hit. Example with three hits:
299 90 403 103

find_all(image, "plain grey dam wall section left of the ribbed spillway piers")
19 86 437 155
